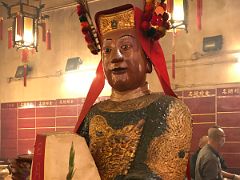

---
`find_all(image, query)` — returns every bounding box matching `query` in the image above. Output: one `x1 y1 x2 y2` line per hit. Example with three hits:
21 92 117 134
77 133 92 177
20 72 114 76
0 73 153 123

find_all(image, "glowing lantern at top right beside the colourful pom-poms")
167 0 188 32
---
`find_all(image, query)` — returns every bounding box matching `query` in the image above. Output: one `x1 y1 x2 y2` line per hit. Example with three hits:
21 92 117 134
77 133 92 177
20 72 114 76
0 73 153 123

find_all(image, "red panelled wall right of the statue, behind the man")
182 87 240 174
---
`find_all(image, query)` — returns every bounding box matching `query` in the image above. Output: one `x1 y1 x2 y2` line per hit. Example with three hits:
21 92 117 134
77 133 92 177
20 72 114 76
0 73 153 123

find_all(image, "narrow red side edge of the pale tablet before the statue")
32 134 46 180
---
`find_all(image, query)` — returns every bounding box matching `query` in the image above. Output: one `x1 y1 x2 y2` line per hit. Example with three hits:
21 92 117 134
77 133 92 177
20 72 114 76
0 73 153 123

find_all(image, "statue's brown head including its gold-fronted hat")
97 6 152 91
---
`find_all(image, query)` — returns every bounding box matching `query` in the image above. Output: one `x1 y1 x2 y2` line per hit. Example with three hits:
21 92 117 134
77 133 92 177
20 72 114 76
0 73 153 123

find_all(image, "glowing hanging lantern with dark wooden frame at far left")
2 0 44 51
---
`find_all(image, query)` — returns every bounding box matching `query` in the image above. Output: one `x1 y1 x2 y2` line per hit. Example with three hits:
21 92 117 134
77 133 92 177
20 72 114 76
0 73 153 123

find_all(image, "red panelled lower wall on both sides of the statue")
1 86 240 173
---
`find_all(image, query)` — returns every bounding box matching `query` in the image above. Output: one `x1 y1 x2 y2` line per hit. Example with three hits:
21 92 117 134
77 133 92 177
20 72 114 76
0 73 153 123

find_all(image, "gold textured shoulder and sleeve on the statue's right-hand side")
147 95 192 180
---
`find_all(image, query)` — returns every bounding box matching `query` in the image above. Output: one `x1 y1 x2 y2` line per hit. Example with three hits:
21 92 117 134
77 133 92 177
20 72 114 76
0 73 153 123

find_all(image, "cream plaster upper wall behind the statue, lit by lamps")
0 0 240 102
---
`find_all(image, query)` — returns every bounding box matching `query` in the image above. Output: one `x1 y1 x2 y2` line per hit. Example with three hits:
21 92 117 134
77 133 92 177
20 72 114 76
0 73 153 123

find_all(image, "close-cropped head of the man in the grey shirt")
208 126 226 149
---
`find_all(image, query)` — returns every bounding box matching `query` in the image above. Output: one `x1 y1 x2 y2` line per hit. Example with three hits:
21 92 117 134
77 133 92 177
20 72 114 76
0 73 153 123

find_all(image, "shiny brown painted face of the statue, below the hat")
102 29 149 91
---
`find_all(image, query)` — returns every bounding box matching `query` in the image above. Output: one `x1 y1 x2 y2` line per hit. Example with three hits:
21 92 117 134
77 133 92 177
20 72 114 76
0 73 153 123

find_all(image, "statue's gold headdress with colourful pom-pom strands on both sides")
77 0 170 54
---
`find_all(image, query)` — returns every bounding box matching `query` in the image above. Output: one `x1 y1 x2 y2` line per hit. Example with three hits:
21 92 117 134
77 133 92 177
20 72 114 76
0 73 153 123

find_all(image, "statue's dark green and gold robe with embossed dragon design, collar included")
78 93 192 180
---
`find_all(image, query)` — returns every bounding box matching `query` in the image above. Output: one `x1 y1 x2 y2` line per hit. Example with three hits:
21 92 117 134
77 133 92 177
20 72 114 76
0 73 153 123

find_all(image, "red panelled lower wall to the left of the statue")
1 97 107 158
